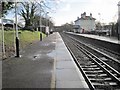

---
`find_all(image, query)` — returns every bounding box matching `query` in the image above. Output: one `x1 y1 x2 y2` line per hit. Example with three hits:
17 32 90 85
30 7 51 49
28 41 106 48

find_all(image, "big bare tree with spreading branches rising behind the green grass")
19 0 56 29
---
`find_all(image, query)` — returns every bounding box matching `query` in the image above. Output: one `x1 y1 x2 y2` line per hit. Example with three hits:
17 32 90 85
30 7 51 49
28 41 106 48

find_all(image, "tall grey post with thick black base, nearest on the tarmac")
15 0 20 57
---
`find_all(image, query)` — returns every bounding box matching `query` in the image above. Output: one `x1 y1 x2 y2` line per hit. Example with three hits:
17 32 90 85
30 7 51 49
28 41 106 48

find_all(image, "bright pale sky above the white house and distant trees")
51 0 119 25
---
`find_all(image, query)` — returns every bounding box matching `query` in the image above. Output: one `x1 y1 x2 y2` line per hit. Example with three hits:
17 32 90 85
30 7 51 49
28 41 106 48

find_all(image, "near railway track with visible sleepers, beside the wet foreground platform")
61 33 120 90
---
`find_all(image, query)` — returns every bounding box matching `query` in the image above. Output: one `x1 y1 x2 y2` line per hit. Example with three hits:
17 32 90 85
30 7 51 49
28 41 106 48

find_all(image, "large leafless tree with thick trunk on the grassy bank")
19 0 57 29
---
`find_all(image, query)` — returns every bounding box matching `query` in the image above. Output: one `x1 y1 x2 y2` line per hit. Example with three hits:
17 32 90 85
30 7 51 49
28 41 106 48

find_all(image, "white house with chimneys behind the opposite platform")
75 12 96 32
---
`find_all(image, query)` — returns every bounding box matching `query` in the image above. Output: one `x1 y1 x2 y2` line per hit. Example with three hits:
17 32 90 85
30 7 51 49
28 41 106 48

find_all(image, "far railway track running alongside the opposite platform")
65 32 120 72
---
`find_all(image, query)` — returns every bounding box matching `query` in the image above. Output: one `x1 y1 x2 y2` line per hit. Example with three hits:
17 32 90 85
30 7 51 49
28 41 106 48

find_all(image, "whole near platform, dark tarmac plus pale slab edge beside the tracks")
2 32 89 90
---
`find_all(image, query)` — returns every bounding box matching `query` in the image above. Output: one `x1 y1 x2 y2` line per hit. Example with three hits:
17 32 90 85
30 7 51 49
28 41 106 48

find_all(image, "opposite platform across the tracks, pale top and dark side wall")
67 32 120 54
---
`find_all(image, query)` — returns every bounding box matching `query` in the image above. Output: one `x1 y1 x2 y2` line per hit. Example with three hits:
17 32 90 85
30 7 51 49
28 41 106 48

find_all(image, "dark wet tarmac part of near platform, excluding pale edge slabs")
2 34 56 88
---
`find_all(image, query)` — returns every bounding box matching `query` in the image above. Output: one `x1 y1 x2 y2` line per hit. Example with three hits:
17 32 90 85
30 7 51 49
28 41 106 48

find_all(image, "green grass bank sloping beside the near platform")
0 30 45 57
